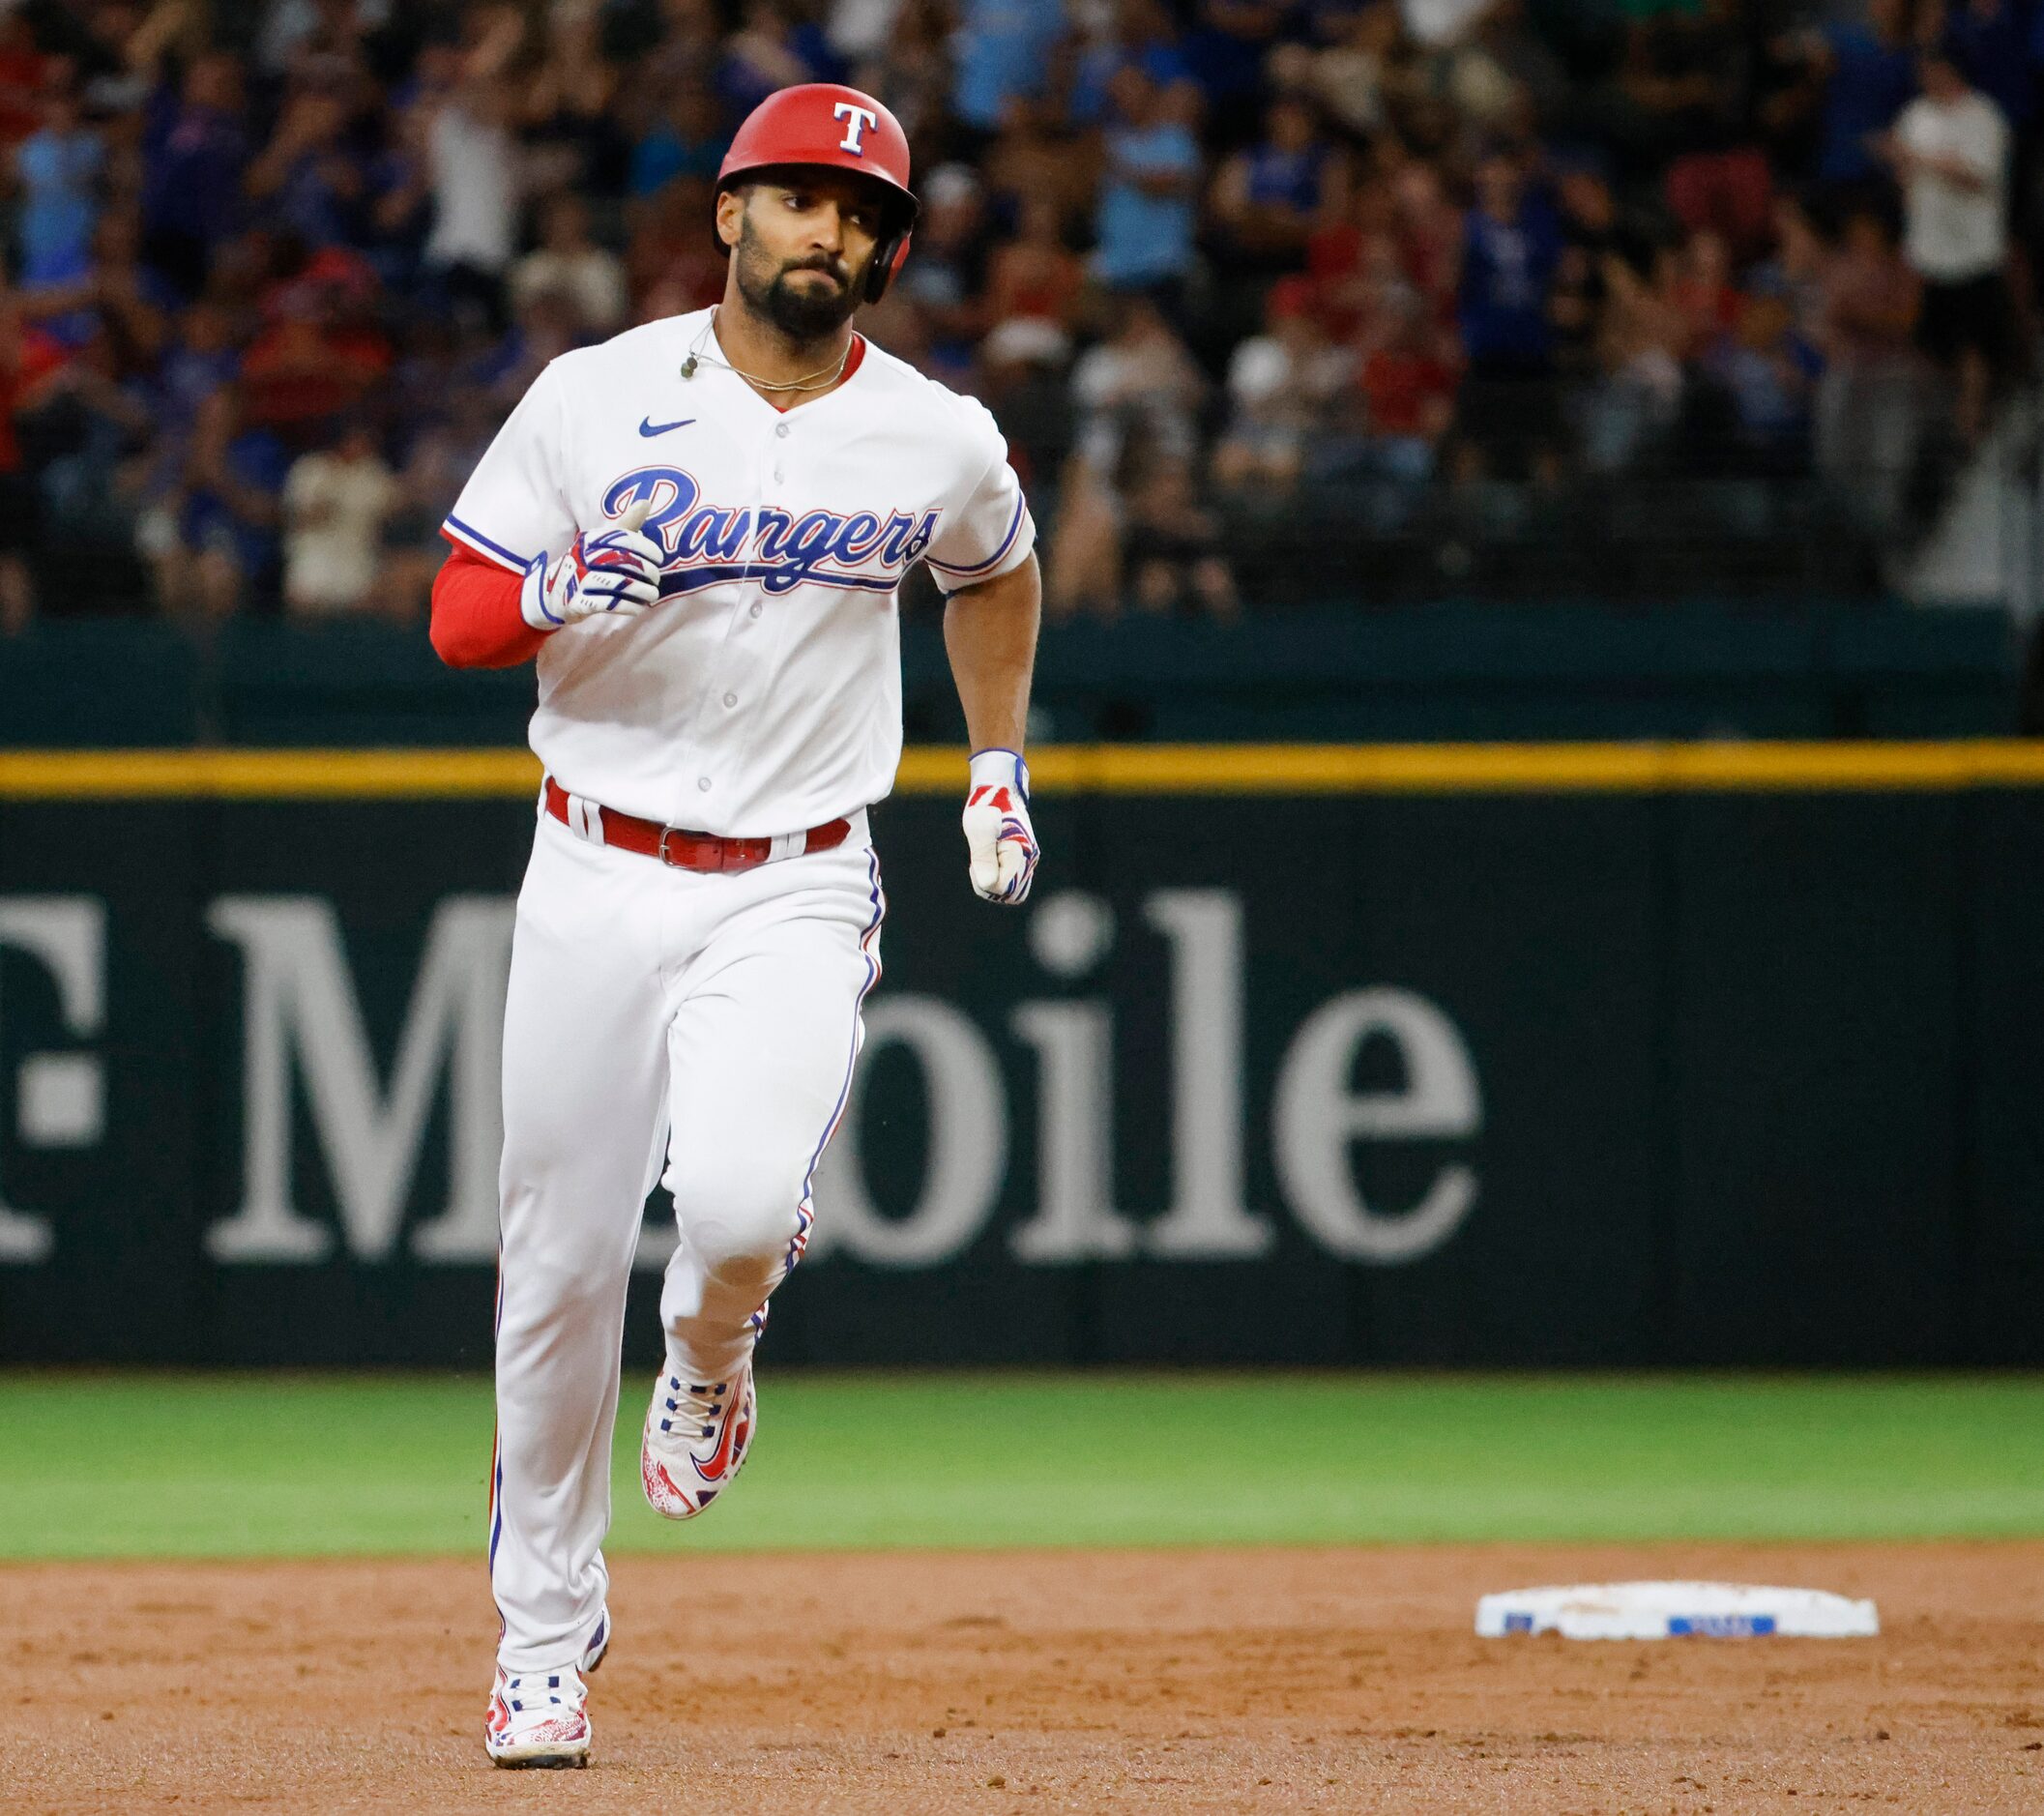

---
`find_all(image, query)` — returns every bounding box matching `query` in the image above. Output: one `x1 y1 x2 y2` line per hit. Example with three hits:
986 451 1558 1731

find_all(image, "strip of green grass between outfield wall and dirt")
0 1370 2044 1559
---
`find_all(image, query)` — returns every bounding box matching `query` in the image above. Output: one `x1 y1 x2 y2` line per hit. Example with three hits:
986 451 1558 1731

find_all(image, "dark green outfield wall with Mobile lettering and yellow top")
0 743 2044 1364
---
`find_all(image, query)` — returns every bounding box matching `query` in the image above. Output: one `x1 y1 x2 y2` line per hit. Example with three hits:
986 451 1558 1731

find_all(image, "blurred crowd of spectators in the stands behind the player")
0 0 2044 628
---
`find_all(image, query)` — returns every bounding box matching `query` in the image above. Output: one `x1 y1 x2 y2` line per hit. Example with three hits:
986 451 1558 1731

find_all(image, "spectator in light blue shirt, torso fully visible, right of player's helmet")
1094 64 1200 292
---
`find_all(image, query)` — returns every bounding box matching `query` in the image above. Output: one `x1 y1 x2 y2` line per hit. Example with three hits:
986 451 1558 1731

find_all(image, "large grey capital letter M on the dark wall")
207 895 513 1262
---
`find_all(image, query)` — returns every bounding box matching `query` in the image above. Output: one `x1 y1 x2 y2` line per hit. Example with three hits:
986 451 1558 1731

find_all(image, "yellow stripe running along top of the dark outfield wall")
0 738 2044 800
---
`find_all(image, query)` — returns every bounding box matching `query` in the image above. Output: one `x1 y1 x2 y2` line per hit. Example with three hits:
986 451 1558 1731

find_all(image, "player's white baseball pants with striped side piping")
490 814 883 1673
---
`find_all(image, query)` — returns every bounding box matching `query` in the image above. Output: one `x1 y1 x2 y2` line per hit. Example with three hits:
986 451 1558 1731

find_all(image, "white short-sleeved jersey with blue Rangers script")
446 308 1037 838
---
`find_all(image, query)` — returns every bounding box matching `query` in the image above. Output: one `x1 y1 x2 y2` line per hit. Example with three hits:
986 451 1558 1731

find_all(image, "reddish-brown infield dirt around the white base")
15 1544 2044 1816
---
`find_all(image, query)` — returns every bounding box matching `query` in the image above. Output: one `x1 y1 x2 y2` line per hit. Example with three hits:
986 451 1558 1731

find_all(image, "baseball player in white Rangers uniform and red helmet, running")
433 84 1040 1765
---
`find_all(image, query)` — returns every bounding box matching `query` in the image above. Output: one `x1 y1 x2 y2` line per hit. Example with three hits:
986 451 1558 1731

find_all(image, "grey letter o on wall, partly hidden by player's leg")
811 996 1007 1268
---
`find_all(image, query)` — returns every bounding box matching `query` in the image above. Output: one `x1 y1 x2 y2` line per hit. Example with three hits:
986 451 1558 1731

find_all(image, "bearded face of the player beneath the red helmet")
717 170 883 341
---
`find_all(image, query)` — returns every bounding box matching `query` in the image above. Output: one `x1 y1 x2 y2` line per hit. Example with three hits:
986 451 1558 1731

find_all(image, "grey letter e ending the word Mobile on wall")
1271 987 1484 1264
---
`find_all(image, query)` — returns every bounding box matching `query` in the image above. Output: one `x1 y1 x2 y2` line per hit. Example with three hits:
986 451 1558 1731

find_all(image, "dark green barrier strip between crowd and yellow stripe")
0 598 2022 748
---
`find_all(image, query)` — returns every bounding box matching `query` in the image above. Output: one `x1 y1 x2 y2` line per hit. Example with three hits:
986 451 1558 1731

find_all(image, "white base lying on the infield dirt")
1475 1583 1881 1640
